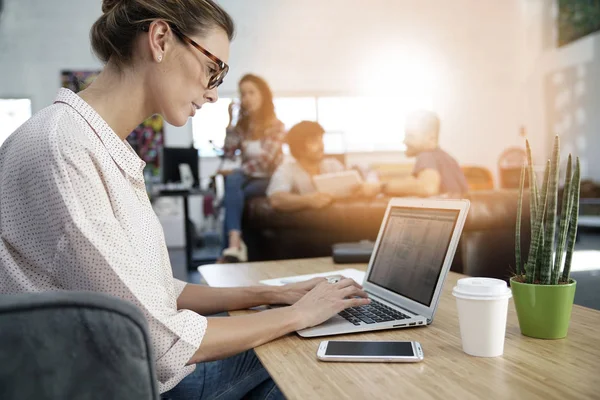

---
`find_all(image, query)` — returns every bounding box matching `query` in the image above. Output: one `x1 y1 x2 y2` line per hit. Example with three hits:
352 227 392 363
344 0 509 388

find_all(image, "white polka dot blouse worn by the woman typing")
0 89 207 392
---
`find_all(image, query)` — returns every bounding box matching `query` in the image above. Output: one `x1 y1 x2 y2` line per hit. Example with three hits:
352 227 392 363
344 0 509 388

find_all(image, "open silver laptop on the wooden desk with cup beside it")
298 198 470 337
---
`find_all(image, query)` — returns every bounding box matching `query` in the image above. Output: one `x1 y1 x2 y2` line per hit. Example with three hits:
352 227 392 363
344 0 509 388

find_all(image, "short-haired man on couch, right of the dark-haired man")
382 111 468 197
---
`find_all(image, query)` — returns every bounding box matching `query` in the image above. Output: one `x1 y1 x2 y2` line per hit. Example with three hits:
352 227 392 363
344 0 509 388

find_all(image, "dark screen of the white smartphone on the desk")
325 341 415 357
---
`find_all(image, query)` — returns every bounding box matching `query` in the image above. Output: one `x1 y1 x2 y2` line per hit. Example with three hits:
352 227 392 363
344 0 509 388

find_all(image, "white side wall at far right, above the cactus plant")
521 0 600 181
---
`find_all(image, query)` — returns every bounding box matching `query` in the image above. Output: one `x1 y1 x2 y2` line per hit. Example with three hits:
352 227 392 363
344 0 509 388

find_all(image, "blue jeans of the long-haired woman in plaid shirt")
223 169 269 248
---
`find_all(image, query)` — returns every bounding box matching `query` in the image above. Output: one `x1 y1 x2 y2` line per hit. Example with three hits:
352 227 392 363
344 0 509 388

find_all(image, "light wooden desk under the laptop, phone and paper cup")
199 259 600 400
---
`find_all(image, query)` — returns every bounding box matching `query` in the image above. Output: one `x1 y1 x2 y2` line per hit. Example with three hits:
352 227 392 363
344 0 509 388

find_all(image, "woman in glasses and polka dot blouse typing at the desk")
0 0 369 399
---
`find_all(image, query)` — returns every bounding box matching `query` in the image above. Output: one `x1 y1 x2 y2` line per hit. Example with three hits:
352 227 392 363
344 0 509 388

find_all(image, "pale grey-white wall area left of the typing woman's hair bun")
0 0 101 112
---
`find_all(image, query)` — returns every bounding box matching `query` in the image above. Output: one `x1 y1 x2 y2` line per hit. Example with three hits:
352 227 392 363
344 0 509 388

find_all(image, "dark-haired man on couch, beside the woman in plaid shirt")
267 121 380 211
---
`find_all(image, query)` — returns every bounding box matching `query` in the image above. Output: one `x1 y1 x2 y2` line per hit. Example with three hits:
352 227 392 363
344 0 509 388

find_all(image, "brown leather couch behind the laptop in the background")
242 190 530 279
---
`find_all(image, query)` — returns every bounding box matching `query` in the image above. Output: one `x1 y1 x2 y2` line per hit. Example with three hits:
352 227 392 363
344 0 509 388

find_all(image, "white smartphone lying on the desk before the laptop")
317 340 423 362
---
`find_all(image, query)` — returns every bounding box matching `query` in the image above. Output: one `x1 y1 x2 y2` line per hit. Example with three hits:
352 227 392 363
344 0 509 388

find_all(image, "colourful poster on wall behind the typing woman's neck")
61 70 164 176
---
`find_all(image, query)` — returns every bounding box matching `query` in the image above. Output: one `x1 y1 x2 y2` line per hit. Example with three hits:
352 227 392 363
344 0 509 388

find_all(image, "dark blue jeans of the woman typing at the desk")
160 350 285 400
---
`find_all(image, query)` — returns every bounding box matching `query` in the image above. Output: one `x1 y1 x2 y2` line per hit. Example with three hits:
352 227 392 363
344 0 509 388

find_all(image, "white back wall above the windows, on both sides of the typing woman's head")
0 0 523 188
